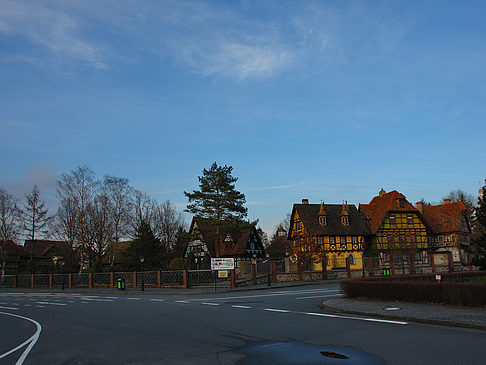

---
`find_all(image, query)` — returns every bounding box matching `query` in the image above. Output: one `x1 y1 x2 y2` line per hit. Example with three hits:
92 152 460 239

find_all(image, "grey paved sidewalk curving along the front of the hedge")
320 298 486 330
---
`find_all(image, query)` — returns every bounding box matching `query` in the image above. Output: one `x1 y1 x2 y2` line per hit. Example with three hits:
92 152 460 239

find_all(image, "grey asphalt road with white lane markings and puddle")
0 284 486 365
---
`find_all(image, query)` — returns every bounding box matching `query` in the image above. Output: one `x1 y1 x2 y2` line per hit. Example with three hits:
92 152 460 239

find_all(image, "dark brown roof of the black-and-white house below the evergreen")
189 217 263 256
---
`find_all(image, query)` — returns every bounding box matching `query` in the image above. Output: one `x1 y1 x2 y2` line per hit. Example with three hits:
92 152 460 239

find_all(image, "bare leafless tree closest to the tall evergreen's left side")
153 200 185 251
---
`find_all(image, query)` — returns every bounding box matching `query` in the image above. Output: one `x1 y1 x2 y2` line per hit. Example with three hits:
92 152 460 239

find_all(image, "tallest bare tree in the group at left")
57 166 99 270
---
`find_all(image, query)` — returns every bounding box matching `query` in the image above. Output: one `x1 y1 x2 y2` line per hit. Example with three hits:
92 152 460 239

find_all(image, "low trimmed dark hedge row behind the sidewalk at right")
341 280 486 307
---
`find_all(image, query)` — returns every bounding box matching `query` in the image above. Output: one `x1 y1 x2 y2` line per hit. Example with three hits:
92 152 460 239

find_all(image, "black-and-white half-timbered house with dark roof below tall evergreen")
186 217 265 262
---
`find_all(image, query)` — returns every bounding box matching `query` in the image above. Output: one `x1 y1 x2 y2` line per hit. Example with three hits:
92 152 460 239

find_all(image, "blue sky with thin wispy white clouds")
0 0 486 233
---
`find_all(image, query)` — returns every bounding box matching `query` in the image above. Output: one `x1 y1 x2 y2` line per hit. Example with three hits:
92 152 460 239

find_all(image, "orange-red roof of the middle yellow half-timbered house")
359 190 418 234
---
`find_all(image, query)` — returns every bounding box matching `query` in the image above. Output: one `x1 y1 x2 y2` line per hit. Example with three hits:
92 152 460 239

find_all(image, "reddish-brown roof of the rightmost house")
422 201 469 234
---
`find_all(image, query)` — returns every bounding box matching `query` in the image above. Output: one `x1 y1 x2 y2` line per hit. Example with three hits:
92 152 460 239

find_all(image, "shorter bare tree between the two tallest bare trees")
87 194 115 271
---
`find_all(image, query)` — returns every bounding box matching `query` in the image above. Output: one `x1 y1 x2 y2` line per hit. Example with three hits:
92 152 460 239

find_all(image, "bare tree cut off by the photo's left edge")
0 188 21 277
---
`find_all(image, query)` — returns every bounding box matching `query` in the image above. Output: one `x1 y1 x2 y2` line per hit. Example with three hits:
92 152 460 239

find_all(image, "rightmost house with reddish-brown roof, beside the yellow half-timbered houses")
417 199 471 265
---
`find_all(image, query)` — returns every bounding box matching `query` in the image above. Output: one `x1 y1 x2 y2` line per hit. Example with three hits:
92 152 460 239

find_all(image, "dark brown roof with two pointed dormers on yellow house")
288 204 369 239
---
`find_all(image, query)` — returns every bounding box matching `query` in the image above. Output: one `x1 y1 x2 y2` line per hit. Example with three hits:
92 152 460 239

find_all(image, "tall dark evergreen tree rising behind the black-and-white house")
184 162 247 222
